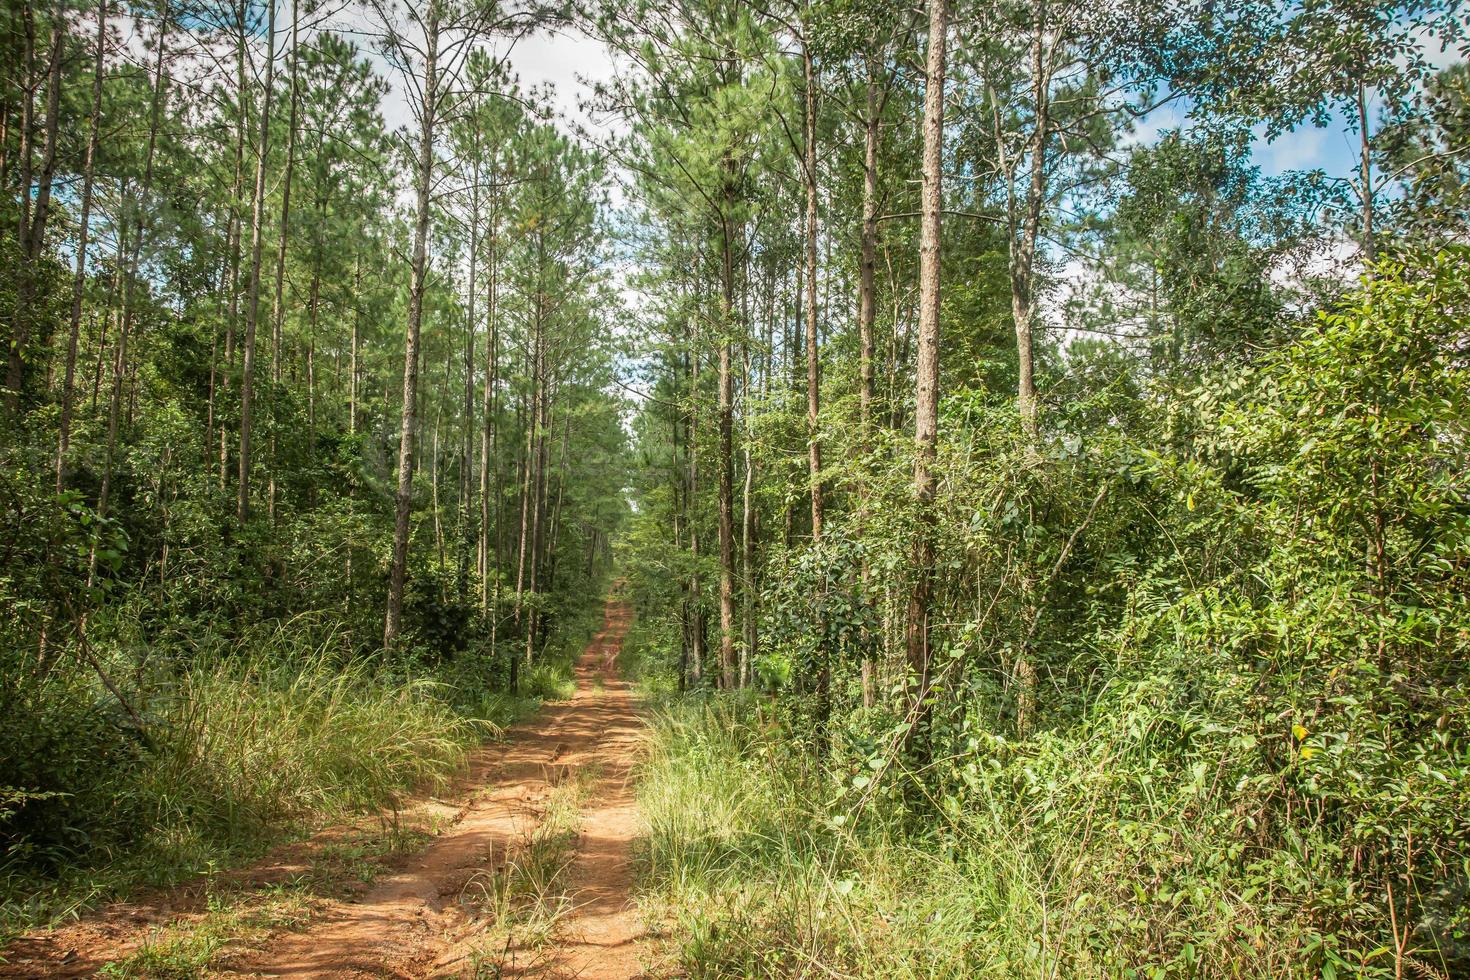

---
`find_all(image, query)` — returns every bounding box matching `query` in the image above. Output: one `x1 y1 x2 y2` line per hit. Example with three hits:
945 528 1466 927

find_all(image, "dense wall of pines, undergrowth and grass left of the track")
0 1 626 911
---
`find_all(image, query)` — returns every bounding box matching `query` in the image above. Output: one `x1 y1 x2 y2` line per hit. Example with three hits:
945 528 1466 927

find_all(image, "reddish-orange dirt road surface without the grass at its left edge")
0 602 644 980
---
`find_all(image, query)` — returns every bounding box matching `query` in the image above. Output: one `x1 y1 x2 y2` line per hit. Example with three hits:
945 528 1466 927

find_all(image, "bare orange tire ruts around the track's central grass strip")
12 601 644 980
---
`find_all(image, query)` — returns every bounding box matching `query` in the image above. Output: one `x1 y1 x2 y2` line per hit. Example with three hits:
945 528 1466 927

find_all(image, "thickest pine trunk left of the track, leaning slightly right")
382 3 440 649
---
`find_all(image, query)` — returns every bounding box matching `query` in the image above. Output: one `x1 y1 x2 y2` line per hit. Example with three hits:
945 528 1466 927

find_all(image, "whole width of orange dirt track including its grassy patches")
0 601 647 980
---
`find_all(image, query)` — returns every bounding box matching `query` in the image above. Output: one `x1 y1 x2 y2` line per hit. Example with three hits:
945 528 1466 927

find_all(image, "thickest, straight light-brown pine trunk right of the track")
907 0 948 738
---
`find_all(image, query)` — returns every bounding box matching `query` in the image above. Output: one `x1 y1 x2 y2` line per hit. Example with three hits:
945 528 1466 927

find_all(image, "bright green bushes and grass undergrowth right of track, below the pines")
634 250 1470 979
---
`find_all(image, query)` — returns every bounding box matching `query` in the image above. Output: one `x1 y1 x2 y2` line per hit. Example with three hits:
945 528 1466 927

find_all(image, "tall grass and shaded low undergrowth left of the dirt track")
0 629 554 933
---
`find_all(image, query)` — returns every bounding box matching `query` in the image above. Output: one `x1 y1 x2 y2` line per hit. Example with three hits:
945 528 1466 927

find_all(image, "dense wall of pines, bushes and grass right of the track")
612 3 1470 976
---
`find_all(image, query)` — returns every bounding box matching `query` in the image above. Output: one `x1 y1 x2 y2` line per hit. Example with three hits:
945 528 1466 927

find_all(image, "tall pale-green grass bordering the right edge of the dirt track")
638 702 1045 977
